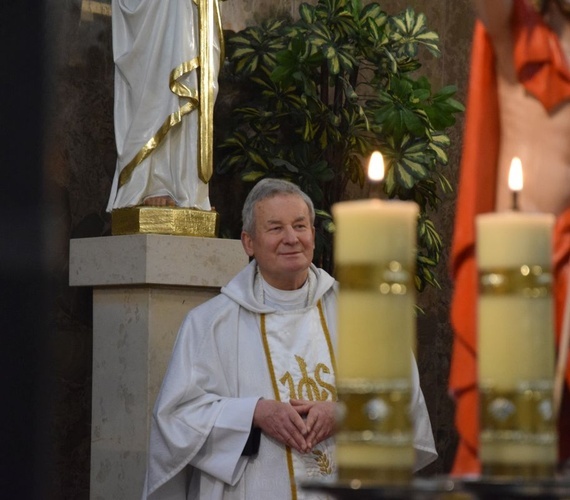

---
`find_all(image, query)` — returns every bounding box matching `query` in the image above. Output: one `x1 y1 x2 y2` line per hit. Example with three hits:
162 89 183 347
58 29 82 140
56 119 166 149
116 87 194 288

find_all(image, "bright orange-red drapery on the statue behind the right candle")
449 0 570 474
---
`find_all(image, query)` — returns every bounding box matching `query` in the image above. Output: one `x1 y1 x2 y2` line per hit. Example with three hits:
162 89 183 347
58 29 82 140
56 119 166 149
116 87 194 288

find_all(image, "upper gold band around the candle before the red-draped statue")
479 264 552 299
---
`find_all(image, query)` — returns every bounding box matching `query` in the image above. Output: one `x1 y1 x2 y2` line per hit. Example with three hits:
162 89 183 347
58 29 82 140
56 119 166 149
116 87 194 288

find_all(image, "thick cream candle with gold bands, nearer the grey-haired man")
332 199 418 484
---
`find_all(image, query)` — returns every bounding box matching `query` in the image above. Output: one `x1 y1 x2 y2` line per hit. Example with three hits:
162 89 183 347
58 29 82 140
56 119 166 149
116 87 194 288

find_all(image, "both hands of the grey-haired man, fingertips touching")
253 399 336 453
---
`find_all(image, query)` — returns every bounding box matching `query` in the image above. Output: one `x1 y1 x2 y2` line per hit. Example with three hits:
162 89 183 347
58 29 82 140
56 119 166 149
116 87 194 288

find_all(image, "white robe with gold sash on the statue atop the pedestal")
107 0 220 211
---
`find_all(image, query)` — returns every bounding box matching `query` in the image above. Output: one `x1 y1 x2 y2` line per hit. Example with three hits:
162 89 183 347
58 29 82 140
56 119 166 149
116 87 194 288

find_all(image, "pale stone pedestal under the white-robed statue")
69 235 248 500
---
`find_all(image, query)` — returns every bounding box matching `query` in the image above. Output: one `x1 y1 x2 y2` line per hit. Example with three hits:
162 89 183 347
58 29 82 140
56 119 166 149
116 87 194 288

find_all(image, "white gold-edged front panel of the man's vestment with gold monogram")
261 301 337 500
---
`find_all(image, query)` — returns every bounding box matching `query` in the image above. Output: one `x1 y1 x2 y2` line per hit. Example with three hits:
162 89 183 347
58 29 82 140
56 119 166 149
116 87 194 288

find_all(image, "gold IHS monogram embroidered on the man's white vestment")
279 356 336 401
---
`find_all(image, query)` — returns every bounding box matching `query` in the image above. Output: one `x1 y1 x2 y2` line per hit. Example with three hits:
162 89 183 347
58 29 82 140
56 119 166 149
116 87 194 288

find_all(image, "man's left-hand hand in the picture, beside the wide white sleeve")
253 399 311 453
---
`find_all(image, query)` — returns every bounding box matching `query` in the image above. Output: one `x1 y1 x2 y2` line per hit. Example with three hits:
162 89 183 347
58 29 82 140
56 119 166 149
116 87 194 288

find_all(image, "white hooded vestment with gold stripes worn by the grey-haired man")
143 261 437 500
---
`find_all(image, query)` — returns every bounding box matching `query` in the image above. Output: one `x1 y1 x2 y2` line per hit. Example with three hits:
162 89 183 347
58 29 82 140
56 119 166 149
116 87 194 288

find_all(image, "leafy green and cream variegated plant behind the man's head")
213 0 464 290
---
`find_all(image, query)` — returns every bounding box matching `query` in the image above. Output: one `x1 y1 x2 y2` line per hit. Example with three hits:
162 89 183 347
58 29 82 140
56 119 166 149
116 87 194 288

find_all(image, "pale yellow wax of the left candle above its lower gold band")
333 199 418 379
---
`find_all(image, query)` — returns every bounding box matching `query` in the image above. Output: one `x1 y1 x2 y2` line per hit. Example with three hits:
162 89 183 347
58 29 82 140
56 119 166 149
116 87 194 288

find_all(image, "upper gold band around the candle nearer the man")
337 260 414 295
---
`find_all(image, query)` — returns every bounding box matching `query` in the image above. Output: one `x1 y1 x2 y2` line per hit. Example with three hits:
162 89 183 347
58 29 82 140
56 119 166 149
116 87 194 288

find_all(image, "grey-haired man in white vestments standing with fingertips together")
145 179 437 500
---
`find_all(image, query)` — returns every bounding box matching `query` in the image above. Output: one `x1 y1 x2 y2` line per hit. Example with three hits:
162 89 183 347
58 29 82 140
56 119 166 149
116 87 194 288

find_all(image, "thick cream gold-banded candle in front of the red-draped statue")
476 212 557 477
